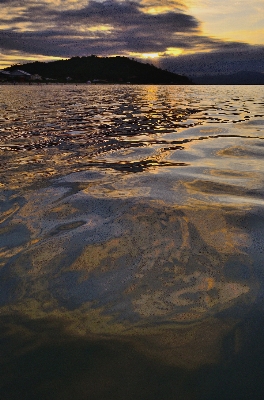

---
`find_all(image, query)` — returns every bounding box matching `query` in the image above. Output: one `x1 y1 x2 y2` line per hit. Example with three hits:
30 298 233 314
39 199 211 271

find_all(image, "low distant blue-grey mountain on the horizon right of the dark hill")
192 71 264 85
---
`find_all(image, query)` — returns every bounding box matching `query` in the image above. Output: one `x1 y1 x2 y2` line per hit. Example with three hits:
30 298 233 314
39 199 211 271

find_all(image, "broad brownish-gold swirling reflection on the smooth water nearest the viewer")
2 194 258 369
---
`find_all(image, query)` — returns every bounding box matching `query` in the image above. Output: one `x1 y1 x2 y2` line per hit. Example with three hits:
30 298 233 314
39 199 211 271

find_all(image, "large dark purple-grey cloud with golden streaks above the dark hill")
0 0 199 57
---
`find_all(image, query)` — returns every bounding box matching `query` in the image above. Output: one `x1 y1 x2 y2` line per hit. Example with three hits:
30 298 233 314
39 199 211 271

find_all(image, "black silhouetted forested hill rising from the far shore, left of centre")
6 56 192 84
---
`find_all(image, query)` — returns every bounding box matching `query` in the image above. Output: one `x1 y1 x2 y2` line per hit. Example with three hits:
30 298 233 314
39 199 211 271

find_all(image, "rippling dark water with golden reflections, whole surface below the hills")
0 86 264 400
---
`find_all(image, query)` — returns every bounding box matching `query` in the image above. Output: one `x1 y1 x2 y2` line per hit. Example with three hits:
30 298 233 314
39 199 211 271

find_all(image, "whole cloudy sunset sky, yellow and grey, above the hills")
0 0 264 75
